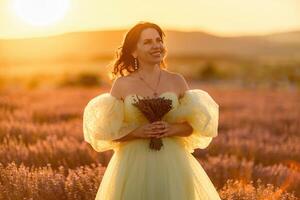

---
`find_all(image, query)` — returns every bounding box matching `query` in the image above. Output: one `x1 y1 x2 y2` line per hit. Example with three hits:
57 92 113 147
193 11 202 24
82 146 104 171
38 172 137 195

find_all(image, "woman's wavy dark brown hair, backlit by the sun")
112 22 166 79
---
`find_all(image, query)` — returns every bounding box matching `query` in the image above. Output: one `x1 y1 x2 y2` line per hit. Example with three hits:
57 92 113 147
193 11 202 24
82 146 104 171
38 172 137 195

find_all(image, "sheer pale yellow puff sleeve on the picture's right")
173 89 219 153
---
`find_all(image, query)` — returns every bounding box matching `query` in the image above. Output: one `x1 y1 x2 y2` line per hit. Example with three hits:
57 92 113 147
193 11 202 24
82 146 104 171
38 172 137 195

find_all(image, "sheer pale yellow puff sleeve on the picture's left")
83 93 137 152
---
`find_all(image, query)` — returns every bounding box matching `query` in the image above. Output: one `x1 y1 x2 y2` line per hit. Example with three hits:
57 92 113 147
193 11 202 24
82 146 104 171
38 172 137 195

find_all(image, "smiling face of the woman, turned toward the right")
133 28 165 64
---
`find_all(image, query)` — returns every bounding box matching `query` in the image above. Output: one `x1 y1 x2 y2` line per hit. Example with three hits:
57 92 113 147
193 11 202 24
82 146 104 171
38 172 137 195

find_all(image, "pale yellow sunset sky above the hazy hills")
0 0 300 38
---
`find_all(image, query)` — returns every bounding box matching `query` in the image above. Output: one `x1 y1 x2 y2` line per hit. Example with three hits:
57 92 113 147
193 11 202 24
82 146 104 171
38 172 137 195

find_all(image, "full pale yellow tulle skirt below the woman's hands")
96 138 220 200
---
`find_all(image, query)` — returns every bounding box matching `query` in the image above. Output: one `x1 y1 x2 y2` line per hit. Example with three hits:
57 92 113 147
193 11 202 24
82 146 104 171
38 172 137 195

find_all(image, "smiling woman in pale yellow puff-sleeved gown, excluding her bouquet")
83 22 220 200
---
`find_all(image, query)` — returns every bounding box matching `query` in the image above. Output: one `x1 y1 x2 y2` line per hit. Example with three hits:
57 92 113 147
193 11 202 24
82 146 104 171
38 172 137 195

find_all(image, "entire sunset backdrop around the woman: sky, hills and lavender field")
0 0 300 199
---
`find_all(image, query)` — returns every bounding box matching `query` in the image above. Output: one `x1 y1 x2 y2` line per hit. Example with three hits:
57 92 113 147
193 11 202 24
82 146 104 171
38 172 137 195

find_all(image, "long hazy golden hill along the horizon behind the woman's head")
0 30 300 64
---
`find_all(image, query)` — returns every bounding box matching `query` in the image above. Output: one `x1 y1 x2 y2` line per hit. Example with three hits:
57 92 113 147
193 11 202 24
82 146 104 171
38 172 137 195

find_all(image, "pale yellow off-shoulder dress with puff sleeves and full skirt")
83 89 220 200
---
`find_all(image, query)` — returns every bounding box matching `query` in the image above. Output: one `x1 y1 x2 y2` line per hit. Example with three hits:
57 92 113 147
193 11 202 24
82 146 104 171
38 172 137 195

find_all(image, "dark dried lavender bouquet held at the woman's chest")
132 95 172 150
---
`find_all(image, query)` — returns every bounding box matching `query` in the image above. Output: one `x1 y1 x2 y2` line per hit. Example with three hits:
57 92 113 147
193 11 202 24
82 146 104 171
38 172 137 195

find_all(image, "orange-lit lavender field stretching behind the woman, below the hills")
0 84 300 200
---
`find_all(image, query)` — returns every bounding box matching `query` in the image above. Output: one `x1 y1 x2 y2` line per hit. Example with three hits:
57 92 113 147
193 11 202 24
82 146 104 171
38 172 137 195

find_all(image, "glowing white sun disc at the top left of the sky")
13 0 70 26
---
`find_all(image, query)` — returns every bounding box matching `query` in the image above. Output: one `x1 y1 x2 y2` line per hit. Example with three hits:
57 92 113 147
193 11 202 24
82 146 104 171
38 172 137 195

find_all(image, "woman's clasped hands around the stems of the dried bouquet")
132 122 168 138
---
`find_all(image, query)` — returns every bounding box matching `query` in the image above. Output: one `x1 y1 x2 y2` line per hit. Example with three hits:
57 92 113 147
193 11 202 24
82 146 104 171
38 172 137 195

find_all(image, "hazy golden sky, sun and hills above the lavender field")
0 0 300 88
